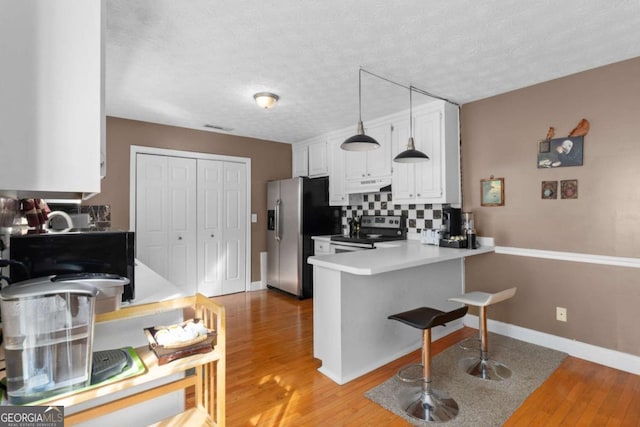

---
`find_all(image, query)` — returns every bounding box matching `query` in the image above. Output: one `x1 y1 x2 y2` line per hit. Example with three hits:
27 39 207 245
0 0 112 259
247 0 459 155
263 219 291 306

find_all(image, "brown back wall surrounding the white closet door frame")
87 117 291 281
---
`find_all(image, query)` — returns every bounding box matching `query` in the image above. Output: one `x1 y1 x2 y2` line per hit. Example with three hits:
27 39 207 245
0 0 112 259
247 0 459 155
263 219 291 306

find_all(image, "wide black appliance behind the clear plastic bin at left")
9 231 135 301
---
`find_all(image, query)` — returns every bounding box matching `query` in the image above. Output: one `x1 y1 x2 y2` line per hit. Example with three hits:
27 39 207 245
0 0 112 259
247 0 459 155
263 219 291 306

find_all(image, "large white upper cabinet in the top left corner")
0 0 105 198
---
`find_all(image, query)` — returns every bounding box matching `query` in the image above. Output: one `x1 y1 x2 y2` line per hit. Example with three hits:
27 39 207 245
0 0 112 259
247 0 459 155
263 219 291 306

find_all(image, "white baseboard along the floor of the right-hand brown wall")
463 314 640 375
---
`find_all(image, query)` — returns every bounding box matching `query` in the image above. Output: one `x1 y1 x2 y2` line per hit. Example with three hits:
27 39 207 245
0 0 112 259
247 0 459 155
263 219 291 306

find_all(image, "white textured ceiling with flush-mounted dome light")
105 0 640 142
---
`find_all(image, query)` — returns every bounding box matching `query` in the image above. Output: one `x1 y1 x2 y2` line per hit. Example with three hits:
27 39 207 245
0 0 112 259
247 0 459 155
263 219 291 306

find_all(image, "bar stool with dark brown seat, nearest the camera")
388 306 468 421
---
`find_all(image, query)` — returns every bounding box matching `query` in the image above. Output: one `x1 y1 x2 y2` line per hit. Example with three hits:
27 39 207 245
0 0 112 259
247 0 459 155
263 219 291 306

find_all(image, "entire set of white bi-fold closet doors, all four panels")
136 153 247 296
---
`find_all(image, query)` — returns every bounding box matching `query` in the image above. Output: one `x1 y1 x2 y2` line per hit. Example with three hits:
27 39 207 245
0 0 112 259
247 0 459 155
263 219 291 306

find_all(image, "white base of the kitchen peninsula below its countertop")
314 259 463 384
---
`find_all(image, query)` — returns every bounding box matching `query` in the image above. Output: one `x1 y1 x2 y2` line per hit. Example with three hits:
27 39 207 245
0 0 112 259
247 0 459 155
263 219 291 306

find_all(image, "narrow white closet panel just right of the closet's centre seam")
198 160 224 296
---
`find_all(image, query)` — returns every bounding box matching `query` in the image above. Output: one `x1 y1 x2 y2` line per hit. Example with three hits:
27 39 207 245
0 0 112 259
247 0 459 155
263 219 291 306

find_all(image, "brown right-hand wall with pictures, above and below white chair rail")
461 58 640 355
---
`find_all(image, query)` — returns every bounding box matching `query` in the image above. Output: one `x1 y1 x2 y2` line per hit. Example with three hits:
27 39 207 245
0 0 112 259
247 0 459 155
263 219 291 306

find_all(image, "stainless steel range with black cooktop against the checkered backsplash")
331 215 407 253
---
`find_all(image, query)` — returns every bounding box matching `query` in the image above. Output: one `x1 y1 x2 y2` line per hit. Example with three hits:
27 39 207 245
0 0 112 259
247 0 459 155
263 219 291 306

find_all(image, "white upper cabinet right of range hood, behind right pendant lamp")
391 101 460 204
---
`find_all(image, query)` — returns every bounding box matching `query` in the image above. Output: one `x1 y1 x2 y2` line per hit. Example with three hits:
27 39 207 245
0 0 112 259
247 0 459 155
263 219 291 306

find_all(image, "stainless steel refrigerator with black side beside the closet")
267 177 342 298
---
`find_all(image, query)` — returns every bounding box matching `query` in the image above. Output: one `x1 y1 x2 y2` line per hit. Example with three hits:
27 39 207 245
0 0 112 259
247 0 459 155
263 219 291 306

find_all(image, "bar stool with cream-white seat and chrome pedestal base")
449 287 516 381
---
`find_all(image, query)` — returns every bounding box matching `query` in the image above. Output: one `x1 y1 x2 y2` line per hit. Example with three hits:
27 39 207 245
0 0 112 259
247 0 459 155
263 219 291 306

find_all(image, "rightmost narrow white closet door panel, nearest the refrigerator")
222 162 247 294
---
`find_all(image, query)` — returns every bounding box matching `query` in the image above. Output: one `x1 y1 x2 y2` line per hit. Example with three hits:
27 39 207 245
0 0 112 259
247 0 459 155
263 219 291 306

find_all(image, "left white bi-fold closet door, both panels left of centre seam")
136 154 197 294
